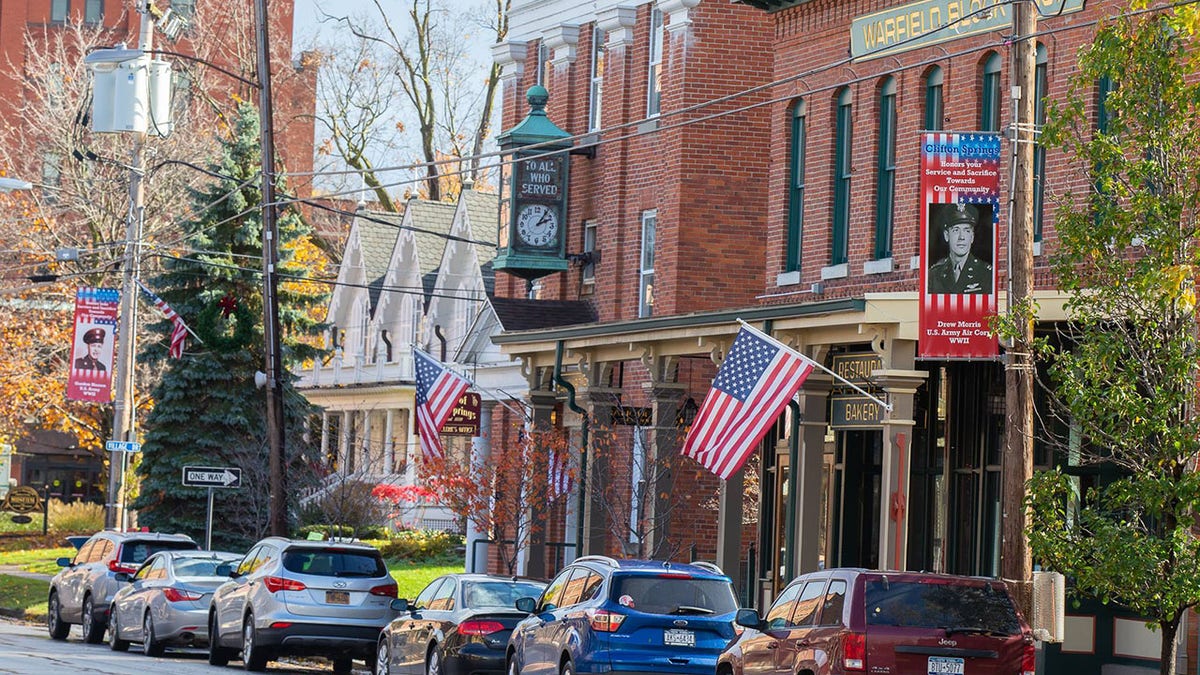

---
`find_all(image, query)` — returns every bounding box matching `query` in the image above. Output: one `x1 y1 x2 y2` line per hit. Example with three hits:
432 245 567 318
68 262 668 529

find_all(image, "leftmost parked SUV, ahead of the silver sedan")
46 530 200 644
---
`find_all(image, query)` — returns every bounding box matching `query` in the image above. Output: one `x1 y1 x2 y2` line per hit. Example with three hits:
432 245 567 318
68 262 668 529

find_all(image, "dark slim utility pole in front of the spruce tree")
254 0 288 537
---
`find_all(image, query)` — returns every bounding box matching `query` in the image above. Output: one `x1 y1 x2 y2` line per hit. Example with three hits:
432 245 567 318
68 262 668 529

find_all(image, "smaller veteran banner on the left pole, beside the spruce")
67 288 121 404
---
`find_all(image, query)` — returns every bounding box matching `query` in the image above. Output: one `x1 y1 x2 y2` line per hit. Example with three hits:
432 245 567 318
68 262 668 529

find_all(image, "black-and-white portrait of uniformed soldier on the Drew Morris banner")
926 204 992 295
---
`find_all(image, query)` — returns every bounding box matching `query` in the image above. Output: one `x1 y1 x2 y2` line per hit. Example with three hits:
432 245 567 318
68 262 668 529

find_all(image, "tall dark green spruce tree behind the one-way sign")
133 103 326 550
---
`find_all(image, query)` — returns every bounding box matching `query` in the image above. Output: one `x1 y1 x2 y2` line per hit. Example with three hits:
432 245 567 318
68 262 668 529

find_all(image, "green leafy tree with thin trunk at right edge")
1025 10 1200 674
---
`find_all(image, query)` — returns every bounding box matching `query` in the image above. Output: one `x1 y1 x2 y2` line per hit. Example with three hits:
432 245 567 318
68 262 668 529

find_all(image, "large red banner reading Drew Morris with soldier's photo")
918 132 1000 359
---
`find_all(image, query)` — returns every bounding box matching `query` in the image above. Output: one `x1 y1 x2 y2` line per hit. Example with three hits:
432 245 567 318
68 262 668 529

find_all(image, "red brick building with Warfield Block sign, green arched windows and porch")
494 0 1194 673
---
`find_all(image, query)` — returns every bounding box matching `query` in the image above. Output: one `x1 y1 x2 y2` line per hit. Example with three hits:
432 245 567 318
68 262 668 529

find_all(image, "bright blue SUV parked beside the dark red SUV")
506 556 738 675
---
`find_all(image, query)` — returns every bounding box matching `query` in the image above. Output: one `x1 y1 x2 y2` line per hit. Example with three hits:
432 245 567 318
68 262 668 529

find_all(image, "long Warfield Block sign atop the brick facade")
850 0 1084 60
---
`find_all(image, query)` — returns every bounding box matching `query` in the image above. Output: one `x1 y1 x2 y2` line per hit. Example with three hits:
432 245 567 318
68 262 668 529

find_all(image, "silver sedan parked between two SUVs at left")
108 551 241 656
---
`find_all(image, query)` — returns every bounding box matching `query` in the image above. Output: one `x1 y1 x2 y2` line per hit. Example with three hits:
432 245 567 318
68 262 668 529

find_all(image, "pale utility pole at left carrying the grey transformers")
104 2 154 530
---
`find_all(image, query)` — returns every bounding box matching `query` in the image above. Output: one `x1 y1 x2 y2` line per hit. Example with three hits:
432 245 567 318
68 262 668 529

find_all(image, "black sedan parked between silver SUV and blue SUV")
376 574 546 675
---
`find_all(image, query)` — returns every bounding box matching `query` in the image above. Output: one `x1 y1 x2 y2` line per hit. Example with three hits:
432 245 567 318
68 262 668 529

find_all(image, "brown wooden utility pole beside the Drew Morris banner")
1000 2 1038 616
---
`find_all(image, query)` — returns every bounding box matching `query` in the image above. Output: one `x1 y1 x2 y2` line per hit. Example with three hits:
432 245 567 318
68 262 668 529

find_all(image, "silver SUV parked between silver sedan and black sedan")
208 537 396 673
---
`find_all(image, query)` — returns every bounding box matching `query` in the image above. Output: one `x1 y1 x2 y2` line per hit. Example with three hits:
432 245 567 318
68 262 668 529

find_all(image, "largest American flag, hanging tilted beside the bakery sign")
683 325 815 479
